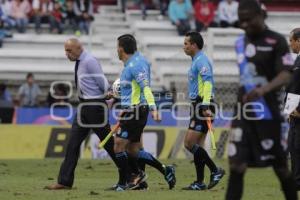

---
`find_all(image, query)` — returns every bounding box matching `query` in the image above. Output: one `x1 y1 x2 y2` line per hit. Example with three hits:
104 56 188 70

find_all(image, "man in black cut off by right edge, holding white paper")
287 28 300 191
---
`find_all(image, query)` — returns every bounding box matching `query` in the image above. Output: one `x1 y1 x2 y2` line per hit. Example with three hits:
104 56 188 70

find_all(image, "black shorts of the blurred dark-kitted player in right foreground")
228 120 287 167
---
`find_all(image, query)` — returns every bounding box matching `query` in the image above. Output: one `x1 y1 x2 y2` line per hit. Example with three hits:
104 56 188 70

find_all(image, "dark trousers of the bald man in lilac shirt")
58 103 115 187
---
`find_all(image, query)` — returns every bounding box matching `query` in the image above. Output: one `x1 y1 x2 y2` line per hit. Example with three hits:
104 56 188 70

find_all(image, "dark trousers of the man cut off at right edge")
288 117 300 190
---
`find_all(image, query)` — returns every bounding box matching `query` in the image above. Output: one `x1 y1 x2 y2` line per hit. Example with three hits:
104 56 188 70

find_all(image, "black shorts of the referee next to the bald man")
116 105 149 142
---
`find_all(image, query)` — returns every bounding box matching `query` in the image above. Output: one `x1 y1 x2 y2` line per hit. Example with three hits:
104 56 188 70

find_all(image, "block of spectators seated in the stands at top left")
0 0 94 40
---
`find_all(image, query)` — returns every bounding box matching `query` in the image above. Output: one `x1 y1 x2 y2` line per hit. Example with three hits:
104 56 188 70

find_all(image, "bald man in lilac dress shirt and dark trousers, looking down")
45 39 115 190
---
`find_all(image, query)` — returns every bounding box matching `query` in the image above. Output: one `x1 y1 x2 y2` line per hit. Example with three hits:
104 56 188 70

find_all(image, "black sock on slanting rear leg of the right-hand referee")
191 144 218 173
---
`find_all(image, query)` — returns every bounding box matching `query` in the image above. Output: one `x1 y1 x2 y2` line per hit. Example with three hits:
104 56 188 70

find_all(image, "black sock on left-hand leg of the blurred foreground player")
226 170 245 200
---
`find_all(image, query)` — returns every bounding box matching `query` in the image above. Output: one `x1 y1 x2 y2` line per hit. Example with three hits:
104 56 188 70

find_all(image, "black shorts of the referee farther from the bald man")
188 101 215 133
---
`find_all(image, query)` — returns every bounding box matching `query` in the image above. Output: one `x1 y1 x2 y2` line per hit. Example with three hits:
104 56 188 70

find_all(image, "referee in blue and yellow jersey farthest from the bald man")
183 32 225 190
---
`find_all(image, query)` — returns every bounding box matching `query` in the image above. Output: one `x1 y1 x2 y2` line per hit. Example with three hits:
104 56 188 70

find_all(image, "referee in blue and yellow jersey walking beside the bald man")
114 34 176 191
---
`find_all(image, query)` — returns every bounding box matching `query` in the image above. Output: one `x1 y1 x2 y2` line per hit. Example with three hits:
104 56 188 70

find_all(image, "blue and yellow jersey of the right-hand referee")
188 51 214 104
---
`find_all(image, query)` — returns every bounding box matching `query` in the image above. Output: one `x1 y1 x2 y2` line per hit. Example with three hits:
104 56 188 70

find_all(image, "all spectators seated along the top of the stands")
0 0 264 41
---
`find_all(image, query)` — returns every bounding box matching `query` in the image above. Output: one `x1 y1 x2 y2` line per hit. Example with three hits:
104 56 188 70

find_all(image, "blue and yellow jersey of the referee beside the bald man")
120 52 155 107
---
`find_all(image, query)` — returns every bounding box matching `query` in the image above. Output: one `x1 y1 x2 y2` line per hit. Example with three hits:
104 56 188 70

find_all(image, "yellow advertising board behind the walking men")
0 125 227 159
